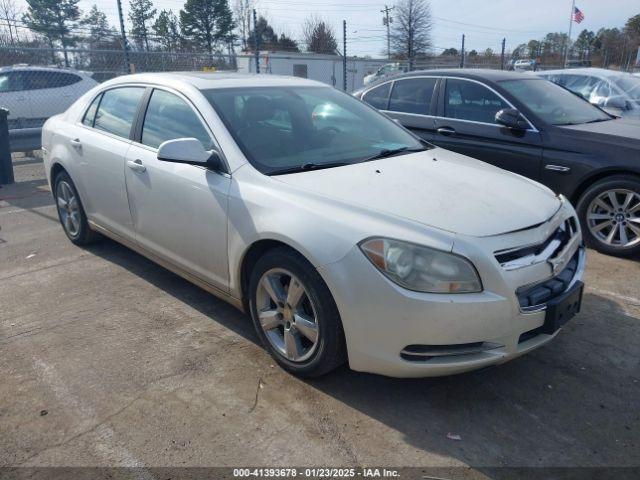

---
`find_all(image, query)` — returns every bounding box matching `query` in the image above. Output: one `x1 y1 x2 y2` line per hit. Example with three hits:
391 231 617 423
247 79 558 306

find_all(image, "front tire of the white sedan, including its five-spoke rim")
249 248 346 377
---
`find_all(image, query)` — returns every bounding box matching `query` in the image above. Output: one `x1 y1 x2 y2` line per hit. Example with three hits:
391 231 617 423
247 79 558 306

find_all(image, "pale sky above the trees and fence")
12 0 640 57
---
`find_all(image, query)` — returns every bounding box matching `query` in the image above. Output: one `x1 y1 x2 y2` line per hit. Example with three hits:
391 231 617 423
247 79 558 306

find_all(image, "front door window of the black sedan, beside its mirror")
444 79 509 123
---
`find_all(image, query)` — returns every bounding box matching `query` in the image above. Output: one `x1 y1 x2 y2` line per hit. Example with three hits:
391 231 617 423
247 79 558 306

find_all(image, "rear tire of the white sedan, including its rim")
53 171 100 246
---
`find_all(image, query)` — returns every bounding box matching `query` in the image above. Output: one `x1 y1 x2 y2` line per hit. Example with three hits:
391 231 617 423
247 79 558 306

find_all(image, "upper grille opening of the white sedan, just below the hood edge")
495 217 578 270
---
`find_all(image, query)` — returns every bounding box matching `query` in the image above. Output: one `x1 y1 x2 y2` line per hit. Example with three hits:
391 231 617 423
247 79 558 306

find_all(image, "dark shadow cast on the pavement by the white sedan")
81 240 640 472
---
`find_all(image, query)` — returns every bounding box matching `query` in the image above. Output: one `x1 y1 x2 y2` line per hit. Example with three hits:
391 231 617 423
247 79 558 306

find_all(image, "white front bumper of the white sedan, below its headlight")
319 201 585 377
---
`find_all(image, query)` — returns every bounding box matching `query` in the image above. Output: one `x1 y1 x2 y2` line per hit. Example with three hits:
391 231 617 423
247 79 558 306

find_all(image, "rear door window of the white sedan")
94 87 144 138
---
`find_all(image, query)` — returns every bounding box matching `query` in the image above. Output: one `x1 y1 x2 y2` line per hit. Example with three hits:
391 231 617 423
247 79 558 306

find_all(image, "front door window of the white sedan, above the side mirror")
142 90 213 149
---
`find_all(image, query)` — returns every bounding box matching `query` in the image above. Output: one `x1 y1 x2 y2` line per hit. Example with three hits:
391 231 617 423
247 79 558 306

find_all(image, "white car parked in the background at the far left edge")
0 66 98 129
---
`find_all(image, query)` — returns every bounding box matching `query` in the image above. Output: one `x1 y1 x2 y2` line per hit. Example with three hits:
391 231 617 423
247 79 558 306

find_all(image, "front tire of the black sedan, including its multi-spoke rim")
576 175 640 257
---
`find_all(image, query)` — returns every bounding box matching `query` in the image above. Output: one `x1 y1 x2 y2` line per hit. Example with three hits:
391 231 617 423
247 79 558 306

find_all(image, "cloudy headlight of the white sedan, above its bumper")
359 238 482 293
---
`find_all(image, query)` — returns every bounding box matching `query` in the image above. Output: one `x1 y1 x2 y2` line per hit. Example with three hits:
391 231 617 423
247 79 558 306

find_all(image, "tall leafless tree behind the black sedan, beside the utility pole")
391 0 433 69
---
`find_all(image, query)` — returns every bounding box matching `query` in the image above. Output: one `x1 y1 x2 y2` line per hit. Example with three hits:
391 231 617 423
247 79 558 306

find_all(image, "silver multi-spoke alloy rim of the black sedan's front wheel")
587 188 640 248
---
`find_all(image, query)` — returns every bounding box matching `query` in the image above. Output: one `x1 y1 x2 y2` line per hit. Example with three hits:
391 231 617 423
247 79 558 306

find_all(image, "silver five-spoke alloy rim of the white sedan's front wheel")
256 268 320 362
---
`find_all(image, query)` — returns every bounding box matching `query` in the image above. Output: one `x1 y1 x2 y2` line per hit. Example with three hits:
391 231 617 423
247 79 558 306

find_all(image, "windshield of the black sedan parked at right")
500 78 612 125
